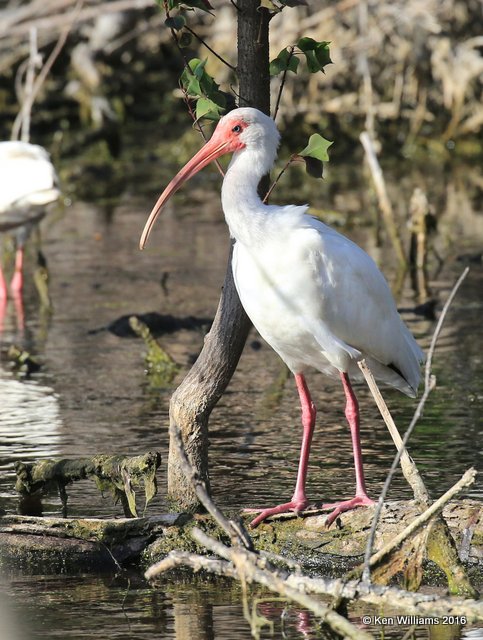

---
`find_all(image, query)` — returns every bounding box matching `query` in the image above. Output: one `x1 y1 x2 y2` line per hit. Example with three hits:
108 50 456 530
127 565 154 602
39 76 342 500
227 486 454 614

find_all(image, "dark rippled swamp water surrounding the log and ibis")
0 136 483 640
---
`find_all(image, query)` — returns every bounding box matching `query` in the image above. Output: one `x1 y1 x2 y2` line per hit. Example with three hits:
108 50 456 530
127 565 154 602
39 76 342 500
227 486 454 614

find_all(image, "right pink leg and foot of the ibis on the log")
322 372 374 525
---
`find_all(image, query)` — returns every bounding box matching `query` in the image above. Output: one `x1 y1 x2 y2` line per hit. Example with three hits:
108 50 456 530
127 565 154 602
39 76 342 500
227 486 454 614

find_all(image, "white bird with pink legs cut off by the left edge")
0 141 60 299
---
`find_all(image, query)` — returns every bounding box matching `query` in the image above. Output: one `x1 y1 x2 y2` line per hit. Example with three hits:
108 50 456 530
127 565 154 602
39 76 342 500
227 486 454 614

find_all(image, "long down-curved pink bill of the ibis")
139 135 230 249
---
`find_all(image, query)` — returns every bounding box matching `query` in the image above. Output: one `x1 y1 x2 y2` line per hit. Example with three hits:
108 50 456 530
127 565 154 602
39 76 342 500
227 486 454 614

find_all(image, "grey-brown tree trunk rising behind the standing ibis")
168 0 270 511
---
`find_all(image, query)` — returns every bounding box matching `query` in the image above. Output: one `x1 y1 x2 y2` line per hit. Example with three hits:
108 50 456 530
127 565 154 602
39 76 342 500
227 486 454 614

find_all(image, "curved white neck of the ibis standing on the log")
221 149 272 246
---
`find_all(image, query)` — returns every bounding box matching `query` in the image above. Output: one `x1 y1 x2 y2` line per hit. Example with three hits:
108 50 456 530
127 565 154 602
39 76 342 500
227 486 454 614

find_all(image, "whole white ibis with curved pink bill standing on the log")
140 108 423 526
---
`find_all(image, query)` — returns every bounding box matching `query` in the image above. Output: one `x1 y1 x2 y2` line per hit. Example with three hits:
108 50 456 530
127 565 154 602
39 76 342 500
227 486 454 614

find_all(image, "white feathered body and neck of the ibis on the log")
222 126 423 396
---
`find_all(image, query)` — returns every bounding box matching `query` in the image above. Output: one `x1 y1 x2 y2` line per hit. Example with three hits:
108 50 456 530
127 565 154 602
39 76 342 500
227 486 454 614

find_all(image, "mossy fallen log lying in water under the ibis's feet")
0 499 483 584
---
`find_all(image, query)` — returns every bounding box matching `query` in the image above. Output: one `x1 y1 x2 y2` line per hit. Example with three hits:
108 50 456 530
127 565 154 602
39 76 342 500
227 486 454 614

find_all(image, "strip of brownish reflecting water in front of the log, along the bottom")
4 573 483 640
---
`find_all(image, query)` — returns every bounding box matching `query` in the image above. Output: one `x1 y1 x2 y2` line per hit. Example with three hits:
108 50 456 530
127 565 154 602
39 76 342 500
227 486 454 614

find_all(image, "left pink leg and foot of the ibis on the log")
250 373 317 527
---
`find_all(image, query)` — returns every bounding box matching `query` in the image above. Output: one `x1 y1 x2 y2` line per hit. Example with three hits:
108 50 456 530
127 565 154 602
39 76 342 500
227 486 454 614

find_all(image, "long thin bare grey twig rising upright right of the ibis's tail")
362 267 469 582
